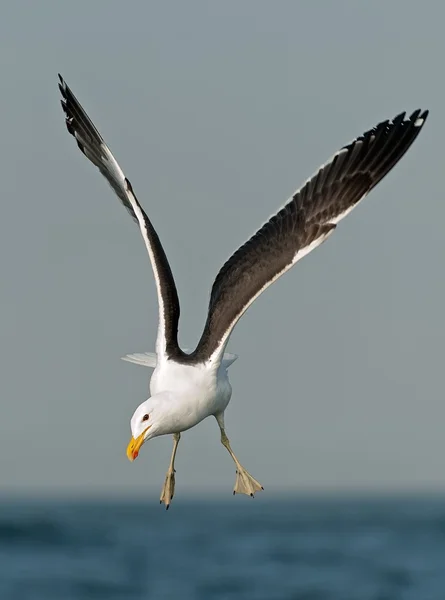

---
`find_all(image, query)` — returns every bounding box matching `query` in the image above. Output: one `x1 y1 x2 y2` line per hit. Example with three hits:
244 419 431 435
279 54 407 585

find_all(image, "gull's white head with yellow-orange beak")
127 392 174 461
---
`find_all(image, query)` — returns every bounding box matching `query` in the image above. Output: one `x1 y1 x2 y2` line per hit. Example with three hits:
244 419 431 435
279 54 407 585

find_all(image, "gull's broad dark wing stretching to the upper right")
189 110 428 364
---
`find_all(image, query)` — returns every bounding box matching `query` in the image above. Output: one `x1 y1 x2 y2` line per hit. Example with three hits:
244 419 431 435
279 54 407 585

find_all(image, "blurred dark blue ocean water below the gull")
0 496 445 600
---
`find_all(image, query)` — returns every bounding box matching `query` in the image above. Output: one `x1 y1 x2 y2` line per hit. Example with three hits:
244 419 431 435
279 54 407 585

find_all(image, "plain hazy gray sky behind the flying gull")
0 0 445 498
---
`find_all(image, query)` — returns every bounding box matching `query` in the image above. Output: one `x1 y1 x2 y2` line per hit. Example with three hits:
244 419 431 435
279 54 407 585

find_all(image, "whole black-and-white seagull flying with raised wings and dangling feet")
59 75 428 509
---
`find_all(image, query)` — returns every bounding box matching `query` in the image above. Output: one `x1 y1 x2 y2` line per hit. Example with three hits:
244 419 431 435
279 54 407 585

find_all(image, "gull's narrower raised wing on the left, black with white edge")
59 75 181 358
